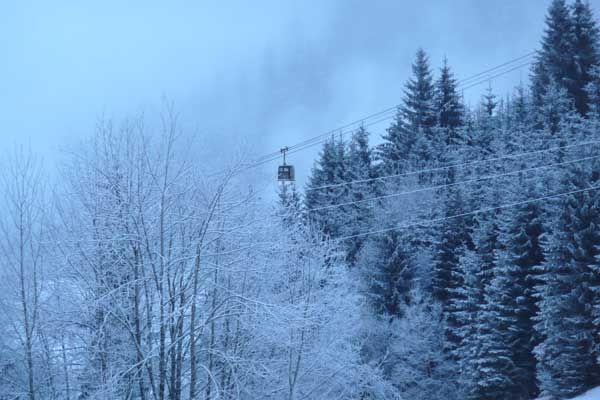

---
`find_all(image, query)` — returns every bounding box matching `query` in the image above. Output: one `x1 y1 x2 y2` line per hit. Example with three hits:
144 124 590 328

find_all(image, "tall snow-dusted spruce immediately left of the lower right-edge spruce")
476 182 543 399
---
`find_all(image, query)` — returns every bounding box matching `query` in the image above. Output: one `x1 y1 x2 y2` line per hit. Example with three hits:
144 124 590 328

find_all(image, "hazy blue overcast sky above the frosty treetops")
0 0 600 188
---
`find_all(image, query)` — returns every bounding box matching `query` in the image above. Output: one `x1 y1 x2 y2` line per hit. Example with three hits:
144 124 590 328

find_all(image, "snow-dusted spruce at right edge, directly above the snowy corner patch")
535 158 600 398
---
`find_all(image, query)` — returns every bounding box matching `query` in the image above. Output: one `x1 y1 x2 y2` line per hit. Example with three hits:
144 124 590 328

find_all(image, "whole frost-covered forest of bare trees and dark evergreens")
0 0 600 400
